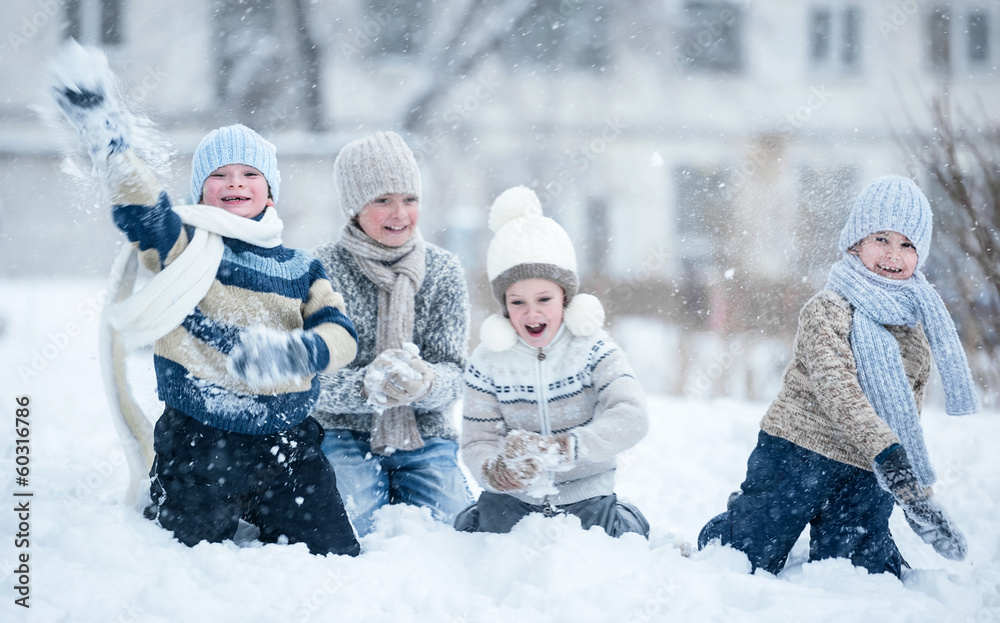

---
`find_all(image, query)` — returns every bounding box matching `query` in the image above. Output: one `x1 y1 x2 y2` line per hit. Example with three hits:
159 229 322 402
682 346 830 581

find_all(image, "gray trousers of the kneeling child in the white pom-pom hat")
455 491 649 538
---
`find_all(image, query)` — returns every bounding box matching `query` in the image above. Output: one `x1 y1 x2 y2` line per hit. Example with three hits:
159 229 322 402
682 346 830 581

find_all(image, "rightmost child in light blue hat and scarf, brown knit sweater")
698 176 979 576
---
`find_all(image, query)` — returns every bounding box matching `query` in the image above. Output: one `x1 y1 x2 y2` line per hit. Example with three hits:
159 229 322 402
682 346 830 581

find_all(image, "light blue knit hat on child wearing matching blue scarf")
840 175 933 268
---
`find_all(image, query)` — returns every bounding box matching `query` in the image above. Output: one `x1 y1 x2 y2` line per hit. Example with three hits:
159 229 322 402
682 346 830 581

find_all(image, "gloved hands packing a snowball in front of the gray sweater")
364 342 435 411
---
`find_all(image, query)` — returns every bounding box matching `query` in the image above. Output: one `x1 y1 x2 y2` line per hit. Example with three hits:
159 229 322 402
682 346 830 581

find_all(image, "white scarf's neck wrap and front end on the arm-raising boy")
110 205 284 348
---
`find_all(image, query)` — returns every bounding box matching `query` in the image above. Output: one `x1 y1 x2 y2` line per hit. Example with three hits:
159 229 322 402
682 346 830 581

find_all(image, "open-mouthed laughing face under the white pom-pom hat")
504 279 565 348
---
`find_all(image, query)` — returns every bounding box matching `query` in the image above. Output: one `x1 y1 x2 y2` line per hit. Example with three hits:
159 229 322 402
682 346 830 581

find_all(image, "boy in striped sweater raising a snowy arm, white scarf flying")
54 46 360 555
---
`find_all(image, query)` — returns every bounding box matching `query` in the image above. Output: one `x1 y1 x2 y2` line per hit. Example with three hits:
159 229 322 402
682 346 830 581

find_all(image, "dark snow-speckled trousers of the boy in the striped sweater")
146 406 361 556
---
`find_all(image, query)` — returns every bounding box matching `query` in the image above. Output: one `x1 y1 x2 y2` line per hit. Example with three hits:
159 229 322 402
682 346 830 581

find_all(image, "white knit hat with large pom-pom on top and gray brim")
486 186 580 308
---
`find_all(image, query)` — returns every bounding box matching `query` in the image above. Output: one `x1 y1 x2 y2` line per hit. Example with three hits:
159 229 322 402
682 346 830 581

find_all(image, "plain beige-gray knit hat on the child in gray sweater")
333 132 421 219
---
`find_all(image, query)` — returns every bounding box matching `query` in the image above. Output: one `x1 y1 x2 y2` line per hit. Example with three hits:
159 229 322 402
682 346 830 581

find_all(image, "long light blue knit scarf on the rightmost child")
826 253 979 486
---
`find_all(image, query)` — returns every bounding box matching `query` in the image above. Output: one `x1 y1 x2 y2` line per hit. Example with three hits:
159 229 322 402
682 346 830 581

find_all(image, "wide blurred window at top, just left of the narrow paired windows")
680 2 743 73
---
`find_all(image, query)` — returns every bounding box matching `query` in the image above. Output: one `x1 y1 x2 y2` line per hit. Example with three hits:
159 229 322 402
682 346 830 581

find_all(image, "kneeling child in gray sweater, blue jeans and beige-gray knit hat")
314 132 472 536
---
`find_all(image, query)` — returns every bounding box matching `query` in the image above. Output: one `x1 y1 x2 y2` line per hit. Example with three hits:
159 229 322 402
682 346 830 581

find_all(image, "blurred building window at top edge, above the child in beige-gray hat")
365 0 430 57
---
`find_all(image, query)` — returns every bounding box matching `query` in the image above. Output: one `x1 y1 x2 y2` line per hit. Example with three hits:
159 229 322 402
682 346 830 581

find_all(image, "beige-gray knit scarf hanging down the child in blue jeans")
341 220 427 454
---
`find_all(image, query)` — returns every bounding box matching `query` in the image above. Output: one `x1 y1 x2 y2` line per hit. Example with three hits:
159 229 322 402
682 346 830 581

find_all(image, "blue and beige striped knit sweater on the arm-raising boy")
112 193 356 435
